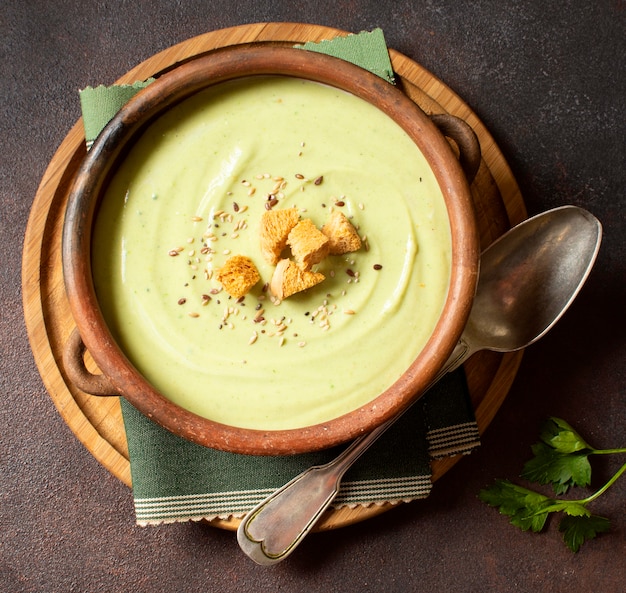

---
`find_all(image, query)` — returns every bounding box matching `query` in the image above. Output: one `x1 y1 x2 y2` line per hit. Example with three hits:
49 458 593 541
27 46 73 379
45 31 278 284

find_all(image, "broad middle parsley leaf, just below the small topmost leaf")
521 443 591 494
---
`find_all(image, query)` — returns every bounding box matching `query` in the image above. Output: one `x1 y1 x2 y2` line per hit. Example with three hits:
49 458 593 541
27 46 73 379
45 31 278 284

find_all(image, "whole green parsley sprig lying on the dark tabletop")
479 418 626 552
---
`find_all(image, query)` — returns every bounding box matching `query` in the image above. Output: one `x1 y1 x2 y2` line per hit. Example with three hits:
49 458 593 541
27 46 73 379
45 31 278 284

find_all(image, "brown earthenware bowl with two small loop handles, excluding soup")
62 45 480 455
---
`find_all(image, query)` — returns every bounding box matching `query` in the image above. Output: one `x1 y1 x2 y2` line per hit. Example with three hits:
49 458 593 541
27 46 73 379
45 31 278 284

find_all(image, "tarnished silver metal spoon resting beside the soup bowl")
237 206 602 565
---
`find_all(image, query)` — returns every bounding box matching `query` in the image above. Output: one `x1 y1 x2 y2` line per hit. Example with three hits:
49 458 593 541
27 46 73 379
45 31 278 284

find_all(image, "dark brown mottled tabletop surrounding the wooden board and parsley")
0 0 626 593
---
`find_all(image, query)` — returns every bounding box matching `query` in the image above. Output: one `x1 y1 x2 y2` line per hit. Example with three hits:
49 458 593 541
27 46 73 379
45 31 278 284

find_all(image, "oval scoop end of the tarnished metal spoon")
462 206 601 354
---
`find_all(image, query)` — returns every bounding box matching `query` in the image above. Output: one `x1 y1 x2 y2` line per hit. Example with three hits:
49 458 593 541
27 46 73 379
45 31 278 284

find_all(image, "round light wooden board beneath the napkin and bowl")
22 23 526 530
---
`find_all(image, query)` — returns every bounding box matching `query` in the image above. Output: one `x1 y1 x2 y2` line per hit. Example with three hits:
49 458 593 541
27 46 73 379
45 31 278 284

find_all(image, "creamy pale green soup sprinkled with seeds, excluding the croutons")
92 77 451 430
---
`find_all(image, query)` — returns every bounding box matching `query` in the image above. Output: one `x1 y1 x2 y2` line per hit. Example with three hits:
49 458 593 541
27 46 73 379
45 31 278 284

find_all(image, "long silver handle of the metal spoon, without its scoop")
237 338 471 565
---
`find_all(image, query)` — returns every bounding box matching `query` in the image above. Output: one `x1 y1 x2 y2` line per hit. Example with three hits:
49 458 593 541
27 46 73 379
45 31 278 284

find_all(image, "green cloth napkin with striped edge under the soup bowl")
80 29 480 525
